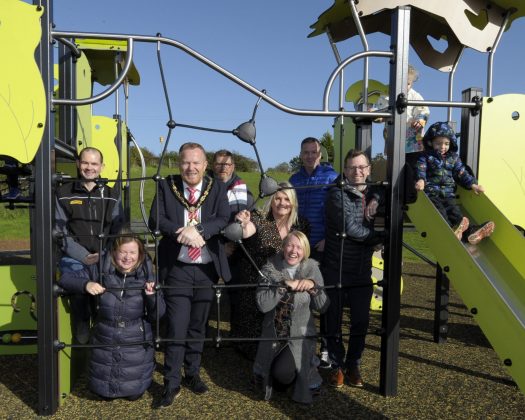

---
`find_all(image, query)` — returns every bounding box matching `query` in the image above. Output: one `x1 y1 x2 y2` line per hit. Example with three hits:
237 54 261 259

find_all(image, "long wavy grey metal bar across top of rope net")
51 31 393 118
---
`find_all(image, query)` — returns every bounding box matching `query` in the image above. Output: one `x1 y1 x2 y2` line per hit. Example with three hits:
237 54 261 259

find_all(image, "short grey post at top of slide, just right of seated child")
459 88 483 176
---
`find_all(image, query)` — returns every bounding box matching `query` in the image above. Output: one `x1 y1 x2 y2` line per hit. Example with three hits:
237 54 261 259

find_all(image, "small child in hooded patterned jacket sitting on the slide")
416 122 495 245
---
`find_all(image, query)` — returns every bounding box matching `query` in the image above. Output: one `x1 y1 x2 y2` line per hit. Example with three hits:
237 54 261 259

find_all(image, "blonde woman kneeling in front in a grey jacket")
254 231 329 404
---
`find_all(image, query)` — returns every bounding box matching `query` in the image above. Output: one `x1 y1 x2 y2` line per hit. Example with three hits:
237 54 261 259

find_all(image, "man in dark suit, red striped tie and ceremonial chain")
149 143 230 407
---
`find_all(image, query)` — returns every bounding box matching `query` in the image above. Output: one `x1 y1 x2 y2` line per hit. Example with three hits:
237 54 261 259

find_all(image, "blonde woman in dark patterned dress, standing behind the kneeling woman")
230 182 310 360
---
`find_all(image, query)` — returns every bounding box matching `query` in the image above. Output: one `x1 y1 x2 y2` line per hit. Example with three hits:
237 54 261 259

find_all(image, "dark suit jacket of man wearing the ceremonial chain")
149 175 231 282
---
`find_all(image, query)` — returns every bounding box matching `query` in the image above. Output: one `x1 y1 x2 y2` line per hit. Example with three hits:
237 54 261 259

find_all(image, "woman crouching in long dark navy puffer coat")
60 234 165 401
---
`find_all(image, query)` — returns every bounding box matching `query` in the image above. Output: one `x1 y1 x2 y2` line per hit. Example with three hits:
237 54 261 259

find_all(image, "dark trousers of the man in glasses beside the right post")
323 268 373 368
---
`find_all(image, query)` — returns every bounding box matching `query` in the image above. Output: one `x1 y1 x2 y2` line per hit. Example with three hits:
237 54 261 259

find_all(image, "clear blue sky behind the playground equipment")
54 0 525 168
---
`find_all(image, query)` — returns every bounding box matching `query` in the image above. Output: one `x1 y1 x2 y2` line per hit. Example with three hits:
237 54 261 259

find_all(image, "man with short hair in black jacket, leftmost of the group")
55 147 123 344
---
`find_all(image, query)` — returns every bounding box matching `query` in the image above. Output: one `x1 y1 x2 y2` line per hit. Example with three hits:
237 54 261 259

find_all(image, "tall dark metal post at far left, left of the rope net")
33 0 58 415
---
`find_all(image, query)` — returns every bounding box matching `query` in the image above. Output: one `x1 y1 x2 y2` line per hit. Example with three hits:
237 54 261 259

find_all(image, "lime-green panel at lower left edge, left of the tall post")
0 265 37 355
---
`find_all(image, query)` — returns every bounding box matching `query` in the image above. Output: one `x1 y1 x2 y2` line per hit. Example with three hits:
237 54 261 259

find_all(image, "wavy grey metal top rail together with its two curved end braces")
51 31 393 118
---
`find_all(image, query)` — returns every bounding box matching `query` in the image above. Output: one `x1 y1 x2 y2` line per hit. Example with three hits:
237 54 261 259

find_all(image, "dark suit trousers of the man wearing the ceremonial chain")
164 263 218 387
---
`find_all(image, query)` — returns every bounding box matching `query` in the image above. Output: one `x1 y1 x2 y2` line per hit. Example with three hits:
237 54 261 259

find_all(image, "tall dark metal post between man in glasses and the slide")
379 7 410 396
